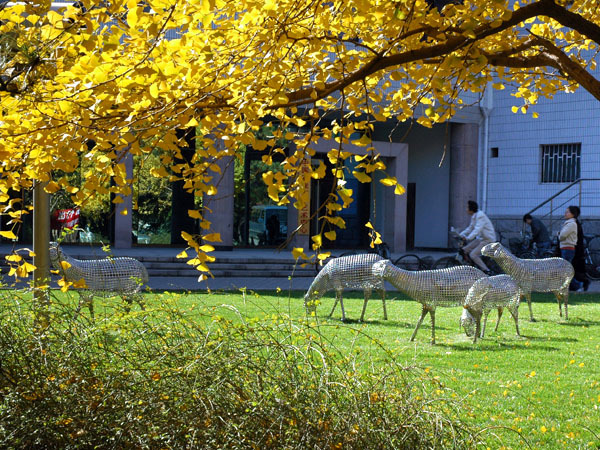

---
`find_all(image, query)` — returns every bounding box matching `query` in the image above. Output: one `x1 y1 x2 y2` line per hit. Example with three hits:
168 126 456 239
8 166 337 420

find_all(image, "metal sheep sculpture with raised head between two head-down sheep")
373 260 486 344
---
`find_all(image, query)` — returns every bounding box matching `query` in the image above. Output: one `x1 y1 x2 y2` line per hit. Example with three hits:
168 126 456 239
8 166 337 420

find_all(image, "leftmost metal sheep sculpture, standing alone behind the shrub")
50 242 148 317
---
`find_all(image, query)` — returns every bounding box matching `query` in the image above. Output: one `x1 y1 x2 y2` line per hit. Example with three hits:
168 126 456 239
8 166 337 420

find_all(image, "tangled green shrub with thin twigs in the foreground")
0 292 486 449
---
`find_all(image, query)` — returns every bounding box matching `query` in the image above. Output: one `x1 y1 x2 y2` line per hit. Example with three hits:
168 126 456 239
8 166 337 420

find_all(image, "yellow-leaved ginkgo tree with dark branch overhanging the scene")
0 0 600 276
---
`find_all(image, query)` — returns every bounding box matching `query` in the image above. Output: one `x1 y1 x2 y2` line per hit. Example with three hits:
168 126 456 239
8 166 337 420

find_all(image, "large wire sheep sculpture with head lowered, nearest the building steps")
304 253 387 322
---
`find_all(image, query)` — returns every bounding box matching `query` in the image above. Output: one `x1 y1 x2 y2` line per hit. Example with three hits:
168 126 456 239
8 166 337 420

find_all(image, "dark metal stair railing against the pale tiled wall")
528 178 600 236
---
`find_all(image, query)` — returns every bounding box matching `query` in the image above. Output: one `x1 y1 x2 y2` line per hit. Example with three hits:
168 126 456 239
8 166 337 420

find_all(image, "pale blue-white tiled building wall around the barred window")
485 82 600 223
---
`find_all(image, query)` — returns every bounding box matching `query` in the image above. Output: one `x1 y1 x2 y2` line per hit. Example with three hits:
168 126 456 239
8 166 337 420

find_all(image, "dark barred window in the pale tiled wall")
541 143 581 183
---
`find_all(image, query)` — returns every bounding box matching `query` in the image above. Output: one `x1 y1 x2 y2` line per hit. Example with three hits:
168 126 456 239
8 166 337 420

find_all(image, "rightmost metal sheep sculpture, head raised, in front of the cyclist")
481 242 575 322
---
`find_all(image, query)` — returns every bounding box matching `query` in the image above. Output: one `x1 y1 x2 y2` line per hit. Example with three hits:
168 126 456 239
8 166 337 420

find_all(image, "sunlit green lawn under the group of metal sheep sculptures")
159 291 600 448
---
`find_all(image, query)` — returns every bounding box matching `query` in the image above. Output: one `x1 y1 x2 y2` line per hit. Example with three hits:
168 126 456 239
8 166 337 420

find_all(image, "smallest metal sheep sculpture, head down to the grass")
460 275 523 343
